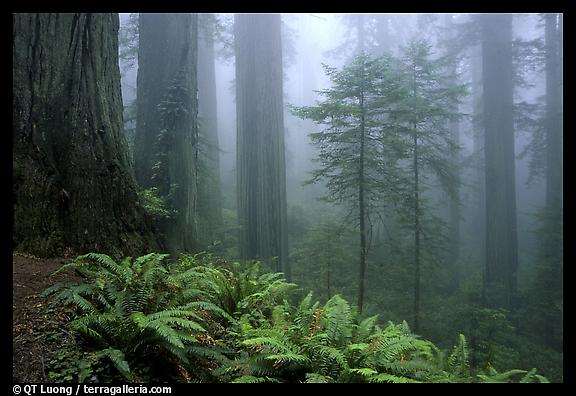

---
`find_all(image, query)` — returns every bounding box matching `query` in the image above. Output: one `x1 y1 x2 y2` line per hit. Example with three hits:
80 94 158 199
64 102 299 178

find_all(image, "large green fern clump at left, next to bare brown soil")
44 253 233 381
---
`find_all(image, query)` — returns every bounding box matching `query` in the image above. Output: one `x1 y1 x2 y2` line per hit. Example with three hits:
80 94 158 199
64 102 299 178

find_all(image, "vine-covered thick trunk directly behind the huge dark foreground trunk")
134 14 198 252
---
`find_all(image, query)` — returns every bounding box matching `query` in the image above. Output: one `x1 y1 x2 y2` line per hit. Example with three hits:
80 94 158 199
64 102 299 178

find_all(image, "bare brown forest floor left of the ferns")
12 253 79 383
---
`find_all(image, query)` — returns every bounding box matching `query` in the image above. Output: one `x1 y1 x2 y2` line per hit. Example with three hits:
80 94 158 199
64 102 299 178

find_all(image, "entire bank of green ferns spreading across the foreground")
45 253 546 382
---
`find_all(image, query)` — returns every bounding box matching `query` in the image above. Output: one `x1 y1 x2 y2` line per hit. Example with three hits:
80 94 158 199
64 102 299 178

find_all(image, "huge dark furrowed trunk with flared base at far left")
12 13 155 256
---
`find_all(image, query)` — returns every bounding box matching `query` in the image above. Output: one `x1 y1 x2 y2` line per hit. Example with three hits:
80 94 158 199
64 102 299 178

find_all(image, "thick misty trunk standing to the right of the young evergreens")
480 14 518 310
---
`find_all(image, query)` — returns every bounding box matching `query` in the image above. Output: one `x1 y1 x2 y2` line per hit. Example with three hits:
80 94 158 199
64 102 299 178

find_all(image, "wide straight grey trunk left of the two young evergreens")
234 14 290 278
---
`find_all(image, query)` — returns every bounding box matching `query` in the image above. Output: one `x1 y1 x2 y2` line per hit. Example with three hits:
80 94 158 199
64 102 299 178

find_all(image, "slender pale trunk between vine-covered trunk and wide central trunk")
198 15 222 245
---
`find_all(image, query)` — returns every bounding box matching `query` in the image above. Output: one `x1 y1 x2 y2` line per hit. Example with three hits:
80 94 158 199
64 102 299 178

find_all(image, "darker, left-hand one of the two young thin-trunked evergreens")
293 55 410 311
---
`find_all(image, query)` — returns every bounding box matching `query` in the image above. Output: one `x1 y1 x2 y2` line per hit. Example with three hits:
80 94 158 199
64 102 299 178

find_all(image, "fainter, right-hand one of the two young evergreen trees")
394 40 466 331
